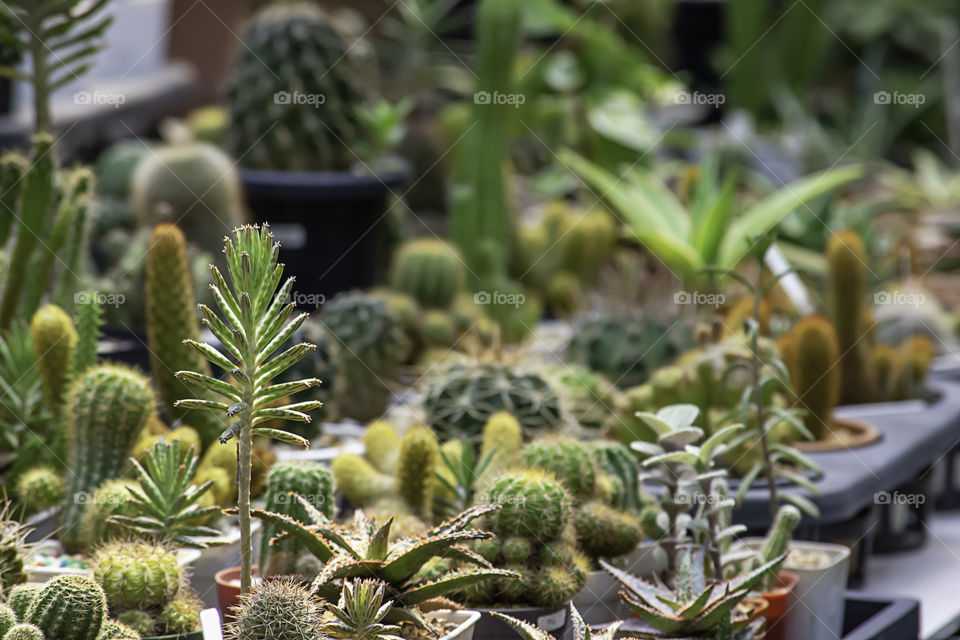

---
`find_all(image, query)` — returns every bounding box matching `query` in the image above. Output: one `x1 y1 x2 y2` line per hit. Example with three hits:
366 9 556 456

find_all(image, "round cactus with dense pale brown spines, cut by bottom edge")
226 578 323 640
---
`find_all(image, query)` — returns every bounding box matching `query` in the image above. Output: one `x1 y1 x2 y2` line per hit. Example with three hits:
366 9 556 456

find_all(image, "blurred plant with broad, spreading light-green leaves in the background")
560 150 863 281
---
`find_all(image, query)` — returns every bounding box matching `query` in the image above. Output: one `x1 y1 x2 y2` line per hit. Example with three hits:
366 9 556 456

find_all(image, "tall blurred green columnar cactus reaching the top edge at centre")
450 0 521 286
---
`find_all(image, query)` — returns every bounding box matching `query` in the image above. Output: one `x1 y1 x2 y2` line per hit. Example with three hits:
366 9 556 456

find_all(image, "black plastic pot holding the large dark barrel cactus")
241 166 410 306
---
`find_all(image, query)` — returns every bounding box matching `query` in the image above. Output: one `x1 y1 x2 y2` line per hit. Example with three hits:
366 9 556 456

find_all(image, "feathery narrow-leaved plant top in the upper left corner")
0 0 113 131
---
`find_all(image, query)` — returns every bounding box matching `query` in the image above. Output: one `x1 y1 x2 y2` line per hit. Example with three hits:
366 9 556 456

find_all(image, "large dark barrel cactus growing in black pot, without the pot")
226 2 369 171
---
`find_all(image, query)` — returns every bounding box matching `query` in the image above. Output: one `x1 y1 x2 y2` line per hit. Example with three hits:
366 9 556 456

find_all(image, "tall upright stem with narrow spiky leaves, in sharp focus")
177 225 321 593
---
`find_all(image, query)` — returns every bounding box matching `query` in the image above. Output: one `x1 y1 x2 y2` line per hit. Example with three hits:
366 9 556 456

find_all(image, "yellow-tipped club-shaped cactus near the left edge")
30 304 77 421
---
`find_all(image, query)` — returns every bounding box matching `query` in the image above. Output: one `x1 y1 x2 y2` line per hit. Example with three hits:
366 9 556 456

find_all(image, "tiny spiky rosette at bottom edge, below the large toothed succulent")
323 580 400 640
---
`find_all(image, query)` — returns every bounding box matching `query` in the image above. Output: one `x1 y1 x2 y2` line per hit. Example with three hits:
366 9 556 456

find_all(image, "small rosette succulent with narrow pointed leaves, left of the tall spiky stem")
108 440 226 549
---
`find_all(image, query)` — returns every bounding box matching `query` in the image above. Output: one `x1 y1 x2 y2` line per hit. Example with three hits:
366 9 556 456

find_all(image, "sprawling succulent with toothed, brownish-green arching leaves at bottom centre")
252 494 518 626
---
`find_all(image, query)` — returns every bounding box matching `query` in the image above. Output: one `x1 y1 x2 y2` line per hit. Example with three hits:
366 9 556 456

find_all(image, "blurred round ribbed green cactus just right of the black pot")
390 238 466 309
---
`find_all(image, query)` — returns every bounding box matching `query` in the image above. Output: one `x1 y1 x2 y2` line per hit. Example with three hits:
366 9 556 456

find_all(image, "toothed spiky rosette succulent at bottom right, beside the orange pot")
600 547 787 640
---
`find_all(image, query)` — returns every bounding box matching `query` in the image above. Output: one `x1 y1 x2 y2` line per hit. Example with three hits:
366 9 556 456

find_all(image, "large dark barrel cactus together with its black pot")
225 2 408 296
